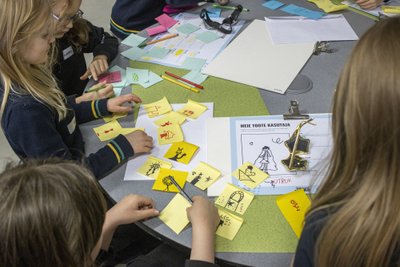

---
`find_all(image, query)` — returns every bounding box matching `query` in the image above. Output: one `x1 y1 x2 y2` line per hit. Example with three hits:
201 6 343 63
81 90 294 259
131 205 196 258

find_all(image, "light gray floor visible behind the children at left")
0 0 115 170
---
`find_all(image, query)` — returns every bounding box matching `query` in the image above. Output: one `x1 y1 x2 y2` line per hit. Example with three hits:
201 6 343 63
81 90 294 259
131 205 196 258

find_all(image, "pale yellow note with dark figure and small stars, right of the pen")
187 161 221 190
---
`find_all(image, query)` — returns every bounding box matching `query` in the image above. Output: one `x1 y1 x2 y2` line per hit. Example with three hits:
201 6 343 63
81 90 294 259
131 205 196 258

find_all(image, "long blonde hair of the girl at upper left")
0 0 67 120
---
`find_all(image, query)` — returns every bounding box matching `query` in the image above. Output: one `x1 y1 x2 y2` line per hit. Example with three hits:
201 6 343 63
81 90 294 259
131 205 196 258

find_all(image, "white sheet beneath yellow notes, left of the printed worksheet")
124 103 212 182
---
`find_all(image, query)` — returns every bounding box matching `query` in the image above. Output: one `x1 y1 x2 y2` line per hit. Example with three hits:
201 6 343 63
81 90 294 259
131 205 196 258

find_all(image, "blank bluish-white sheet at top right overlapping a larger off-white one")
265 15 358 44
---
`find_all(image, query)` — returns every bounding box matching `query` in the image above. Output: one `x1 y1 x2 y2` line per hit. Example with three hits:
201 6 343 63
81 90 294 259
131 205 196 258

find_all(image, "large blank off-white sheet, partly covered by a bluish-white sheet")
203 20 315 94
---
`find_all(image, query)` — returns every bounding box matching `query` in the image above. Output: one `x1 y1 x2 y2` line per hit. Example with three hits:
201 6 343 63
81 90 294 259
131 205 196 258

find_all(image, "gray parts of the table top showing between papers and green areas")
80 0 374 266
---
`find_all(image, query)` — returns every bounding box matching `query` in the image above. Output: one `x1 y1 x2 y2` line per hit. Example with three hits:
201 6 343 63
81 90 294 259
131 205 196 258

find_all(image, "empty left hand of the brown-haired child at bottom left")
106 195 160 226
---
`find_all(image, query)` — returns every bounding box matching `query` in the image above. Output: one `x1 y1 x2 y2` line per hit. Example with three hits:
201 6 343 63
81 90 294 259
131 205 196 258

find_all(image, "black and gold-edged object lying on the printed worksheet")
281 119 315 171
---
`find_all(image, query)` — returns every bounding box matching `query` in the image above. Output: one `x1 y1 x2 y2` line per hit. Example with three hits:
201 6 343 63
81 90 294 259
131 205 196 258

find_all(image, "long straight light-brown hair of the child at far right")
308 17 400 267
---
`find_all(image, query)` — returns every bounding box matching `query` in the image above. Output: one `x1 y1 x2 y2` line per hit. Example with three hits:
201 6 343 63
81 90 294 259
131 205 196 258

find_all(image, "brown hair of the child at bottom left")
0 159 106 267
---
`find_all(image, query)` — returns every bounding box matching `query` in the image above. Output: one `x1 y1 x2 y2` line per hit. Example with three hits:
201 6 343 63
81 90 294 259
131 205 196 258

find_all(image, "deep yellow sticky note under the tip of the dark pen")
152 168 188 193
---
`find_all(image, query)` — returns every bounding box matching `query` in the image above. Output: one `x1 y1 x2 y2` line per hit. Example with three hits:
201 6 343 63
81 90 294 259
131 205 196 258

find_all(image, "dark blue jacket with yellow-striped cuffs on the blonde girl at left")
0 88 134 179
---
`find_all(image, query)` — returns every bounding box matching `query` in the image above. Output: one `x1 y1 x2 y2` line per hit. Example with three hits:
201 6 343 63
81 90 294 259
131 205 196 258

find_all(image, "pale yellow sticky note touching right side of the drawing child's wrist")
216 209 243 240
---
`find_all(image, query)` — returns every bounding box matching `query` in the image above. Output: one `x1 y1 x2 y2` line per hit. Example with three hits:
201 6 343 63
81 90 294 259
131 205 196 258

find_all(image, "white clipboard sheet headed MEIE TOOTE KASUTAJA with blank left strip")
206 114 332 196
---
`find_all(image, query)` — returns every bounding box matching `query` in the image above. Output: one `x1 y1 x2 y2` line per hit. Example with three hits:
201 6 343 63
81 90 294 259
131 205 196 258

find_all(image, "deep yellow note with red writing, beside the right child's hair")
276 189 311 238
